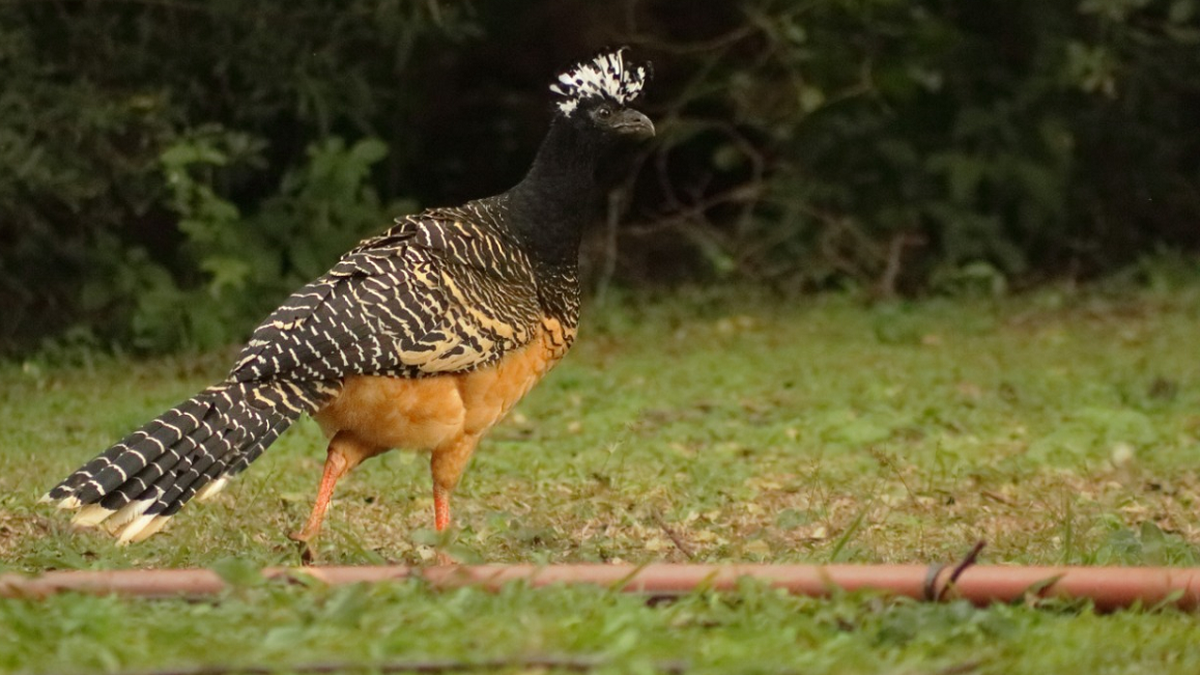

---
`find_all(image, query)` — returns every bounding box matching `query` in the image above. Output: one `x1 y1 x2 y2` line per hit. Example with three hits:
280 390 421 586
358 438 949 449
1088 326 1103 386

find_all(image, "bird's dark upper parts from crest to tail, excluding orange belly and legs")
44 50 654 542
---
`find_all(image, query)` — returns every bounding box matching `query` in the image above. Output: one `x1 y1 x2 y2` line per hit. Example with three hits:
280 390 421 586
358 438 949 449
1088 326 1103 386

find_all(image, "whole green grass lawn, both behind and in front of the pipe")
0 285 1200 674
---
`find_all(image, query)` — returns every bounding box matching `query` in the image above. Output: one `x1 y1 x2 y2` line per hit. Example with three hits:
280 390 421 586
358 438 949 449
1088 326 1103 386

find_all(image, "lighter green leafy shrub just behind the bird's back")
70 127 398 351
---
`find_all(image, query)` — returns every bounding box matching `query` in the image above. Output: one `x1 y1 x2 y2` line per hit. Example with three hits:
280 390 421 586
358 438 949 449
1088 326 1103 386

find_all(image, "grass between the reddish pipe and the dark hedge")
9 285 1200 564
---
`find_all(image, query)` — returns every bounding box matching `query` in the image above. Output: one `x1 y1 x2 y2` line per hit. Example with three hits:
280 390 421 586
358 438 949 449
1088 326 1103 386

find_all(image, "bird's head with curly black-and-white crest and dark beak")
550 47 654 139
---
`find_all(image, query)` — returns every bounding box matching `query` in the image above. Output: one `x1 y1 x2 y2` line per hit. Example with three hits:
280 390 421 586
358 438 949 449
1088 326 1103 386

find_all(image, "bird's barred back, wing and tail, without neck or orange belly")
46 201 547 542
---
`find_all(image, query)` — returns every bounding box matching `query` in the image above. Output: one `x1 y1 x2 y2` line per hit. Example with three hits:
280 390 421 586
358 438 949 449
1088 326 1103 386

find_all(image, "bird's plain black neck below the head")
509 115 607 269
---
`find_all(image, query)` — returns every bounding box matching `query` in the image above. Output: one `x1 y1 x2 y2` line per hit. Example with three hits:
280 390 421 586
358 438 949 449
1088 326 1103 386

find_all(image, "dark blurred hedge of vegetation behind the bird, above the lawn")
0 0 1200 354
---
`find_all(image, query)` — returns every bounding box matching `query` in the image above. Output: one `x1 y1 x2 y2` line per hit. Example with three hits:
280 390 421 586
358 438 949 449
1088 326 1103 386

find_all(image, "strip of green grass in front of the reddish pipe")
0 581 1200 675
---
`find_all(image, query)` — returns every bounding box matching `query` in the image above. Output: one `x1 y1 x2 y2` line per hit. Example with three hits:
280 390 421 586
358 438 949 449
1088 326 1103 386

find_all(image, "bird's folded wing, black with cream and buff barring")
230 216 541 382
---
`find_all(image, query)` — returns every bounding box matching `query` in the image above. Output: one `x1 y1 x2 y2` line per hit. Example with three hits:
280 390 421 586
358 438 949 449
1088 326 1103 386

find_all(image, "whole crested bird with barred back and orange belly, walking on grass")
42 47 655 545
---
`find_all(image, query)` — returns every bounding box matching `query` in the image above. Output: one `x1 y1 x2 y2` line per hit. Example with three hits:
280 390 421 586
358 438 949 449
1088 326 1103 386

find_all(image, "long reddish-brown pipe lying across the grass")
0 558 1200 610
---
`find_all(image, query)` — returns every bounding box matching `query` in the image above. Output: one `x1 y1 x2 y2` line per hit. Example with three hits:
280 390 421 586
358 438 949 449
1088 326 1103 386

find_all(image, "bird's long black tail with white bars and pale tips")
42 381 337 543
